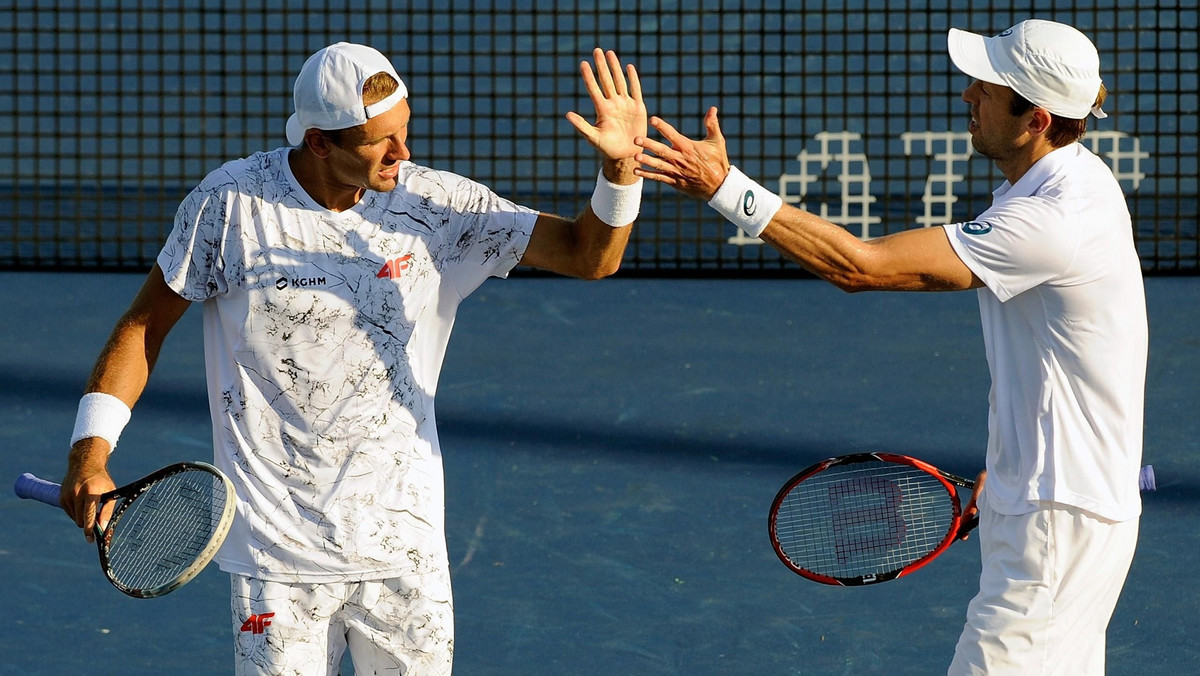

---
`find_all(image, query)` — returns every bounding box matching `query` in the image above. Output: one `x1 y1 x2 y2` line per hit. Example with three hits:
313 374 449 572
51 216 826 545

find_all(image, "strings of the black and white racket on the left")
108 471 226 590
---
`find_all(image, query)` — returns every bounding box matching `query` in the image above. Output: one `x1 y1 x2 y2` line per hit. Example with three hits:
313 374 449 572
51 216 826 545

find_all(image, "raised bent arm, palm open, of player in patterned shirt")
521 48 647 279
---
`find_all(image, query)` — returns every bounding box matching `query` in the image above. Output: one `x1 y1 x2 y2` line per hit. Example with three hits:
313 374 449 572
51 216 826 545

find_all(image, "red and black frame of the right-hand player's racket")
767 453 979 587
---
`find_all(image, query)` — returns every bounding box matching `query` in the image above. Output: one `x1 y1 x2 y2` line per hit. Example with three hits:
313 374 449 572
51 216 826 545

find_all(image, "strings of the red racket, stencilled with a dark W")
775 461 954 578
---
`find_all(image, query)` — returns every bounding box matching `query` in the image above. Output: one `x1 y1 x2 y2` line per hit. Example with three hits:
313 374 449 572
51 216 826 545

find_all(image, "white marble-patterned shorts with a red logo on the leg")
230 573 454 676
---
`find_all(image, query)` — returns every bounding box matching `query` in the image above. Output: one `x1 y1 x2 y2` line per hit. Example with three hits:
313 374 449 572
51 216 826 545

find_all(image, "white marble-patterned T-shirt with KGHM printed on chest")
158 148 538 582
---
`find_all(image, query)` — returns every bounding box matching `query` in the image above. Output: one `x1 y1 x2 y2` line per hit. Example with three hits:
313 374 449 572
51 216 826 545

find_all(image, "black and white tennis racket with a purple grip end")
13 462 235 598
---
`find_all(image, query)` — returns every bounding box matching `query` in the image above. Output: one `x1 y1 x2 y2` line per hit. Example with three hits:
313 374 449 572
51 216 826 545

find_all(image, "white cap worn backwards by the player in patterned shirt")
287 42 408 145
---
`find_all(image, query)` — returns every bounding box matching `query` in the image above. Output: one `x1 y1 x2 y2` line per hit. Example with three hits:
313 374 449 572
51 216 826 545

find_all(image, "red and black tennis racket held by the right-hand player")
768 453 1156 586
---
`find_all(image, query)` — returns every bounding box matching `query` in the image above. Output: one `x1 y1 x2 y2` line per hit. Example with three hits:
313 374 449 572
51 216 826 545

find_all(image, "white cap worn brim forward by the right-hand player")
948 19 1108 120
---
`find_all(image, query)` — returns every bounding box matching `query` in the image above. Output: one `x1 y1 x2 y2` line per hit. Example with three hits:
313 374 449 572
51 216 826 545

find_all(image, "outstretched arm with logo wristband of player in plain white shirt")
635 108 983 292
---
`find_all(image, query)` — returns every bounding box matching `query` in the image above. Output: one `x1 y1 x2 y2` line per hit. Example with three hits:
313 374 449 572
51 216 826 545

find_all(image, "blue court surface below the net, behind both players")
0 273 1200 676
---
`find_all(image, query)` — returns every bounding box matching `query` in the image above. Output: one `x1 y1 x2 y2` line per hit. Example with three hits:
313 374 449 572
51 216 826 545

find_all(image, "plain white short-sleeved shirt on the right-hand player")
943 144 1147 521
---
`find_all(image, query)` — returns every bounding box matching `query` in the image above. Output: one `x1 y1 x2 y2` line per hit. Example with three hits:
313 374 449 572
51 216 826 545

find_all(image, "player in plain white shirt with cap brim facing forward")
637 19 1147 676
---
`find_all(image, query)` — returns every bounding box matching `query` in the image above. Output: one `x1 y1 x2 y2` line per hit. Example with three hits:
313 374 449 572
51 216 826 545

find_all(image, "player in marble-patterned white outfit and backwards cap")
62 43 647 675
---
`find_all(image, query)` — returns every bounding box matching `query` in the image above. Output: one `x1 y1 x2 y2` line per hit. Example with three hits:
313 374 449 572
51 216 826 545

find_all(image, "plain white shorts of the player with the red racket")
949 499 1138 676
